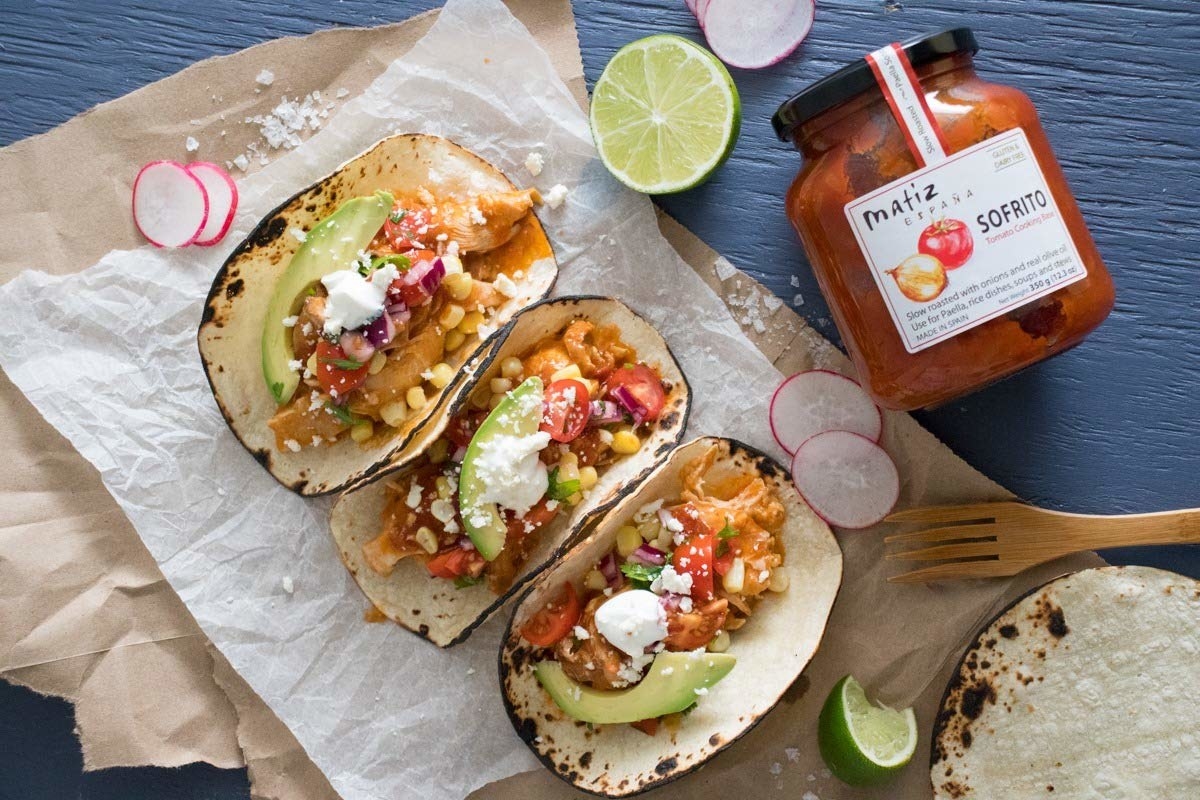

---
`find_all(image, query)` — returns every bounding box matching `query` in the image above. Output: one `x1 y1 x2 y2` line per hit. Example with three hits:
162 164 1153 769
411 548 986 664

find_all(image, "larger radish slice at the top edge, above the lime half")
696 0 816 70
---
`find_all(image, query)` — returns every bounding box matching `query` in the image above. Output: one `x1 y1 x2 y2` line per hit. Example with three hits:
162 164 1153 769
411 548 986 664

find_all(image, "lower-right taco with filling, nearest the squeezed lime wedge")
499 439 841 796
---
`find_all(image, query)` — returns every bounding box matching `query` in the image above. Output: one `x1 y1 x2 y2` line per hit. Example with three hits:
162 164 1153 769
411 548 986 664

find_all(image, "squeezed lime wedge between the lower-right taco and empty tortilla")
817 675 917 786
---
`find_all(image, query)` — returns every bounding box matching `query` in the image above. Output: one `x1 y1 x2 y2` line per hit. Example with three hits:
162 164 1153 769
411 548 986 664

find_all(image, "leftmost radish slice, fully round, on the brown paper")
133 161 209 247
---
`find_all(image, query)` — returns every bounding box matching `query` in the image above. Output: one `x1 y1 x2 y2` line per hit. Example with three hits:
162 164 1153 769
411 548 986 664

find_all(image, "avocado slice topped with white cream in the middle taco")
458 377 548 561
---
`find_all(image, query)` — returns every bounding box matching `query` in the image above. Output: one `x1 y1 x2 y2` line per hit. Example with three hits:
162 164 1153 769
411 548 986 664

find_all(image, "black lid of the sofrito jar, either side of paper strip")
770 28 979 142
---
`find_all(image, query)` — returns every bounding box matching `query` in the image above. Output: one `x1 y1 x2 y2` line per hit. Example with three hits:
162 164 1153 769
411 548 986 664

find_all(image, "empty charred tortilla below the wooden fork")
931 566 1200 800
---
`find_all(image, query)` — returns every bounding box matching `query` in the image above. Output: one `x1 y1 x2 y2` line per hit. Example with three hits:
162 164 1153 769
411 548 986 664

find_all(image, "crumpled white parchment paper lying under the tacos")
0 0 779 800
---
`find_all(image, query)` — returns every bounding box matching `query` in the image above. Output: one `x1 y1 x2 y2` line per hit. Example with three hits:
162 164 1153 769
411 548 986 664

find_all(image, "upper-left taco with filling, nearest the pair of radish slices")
198 134 558 495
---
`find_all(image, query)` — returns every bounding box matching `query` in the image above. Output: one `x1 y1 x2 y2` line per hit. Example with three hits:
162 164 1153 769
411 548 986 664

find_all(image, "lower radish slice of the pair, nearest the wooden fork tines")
792 431 900 529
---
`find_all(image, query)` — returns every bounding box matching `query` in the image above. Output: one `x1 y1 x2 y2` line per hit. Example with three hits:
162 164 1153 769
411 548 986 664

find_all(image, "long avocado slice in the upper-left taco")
263 192 395 405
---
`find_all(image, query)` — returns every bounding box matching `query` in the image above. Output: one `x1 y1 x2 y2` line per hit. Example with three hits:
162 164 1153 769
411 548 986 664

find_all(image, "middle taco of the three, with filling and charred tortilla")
330 297 690 646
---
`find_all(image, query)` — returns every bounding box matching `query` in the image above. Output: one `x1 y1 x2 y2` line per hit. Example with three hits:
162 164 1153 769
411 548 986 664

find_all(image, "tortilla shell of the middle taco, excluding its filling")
330 297 691 646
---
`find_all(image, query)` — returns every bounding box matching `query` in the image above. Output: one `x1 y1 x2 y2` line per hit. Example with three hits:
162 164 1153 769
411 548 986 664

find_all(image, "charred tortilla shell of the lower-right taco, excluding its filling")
499 438 841 798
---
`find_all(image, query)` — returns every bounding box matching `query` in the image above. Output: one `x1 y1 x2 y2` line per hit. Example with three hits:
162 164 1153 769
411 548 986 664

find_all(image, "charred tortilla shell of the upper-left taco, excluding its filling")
198 133 558 495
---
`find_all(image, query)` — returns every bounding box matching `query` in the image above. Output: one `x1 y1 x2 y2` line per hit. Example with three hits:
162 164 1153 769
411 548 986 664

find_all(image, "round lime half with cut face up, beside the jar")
592 34 742 194
